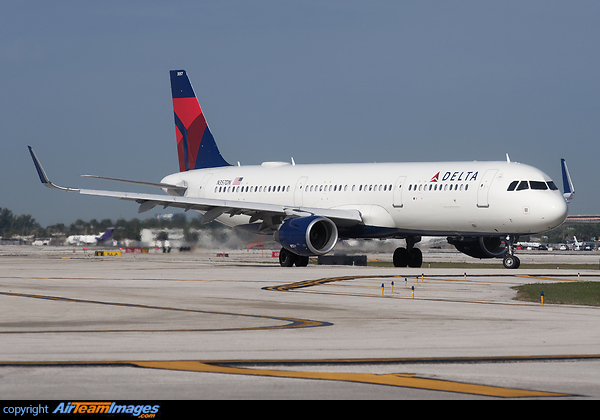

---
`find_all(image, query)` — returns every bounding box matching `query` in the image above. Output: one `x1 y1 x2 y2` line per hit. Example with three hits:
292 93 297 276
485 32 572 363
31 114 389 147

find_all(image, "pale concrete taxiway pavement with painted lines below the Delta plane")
0 246 600 400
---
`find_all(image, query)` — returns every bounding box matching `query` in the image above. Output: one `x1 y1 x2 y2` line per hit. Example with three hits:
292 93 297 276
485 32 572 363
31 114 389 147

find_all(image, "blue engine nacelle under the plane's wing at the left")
274 216 338 256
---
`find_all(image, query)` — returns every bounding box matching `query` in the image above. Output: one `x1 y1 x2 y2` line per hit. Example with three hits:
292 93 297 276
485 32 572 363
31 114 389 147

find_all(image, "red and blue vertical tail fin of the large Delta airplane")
170 70 231 172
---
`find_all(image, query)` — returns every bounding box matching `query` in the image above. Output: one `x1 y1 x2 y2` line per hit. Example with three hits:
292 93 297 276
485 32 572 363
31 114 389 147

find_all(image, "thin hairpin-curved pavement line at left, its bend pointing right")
0 292 332 334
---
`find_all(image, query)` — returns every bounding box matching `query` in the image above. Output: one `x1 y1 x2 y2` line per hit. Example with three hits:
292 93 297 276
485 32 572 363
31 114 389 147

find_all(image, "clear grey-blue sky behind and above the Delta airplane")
0 0 600 226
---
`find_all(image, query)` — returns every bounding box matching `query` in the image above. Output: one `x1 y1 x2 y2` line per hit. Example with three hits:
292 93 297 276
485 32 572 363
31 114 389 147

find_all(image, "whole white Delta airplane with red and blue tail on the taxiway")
29 70 573 268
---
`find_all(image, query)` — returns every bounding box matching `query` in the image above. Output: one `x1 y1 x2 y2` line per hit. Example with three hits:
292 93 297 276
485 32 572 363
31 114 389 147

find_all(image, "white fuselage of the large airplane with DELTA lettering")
161 162 567 238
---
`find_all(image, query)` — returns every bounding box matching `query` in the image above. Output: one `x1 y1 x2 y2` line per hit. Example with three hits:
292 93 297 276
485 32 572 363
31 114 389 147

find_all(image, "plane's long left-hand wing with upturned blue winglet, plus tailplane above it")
28 146 362 231
